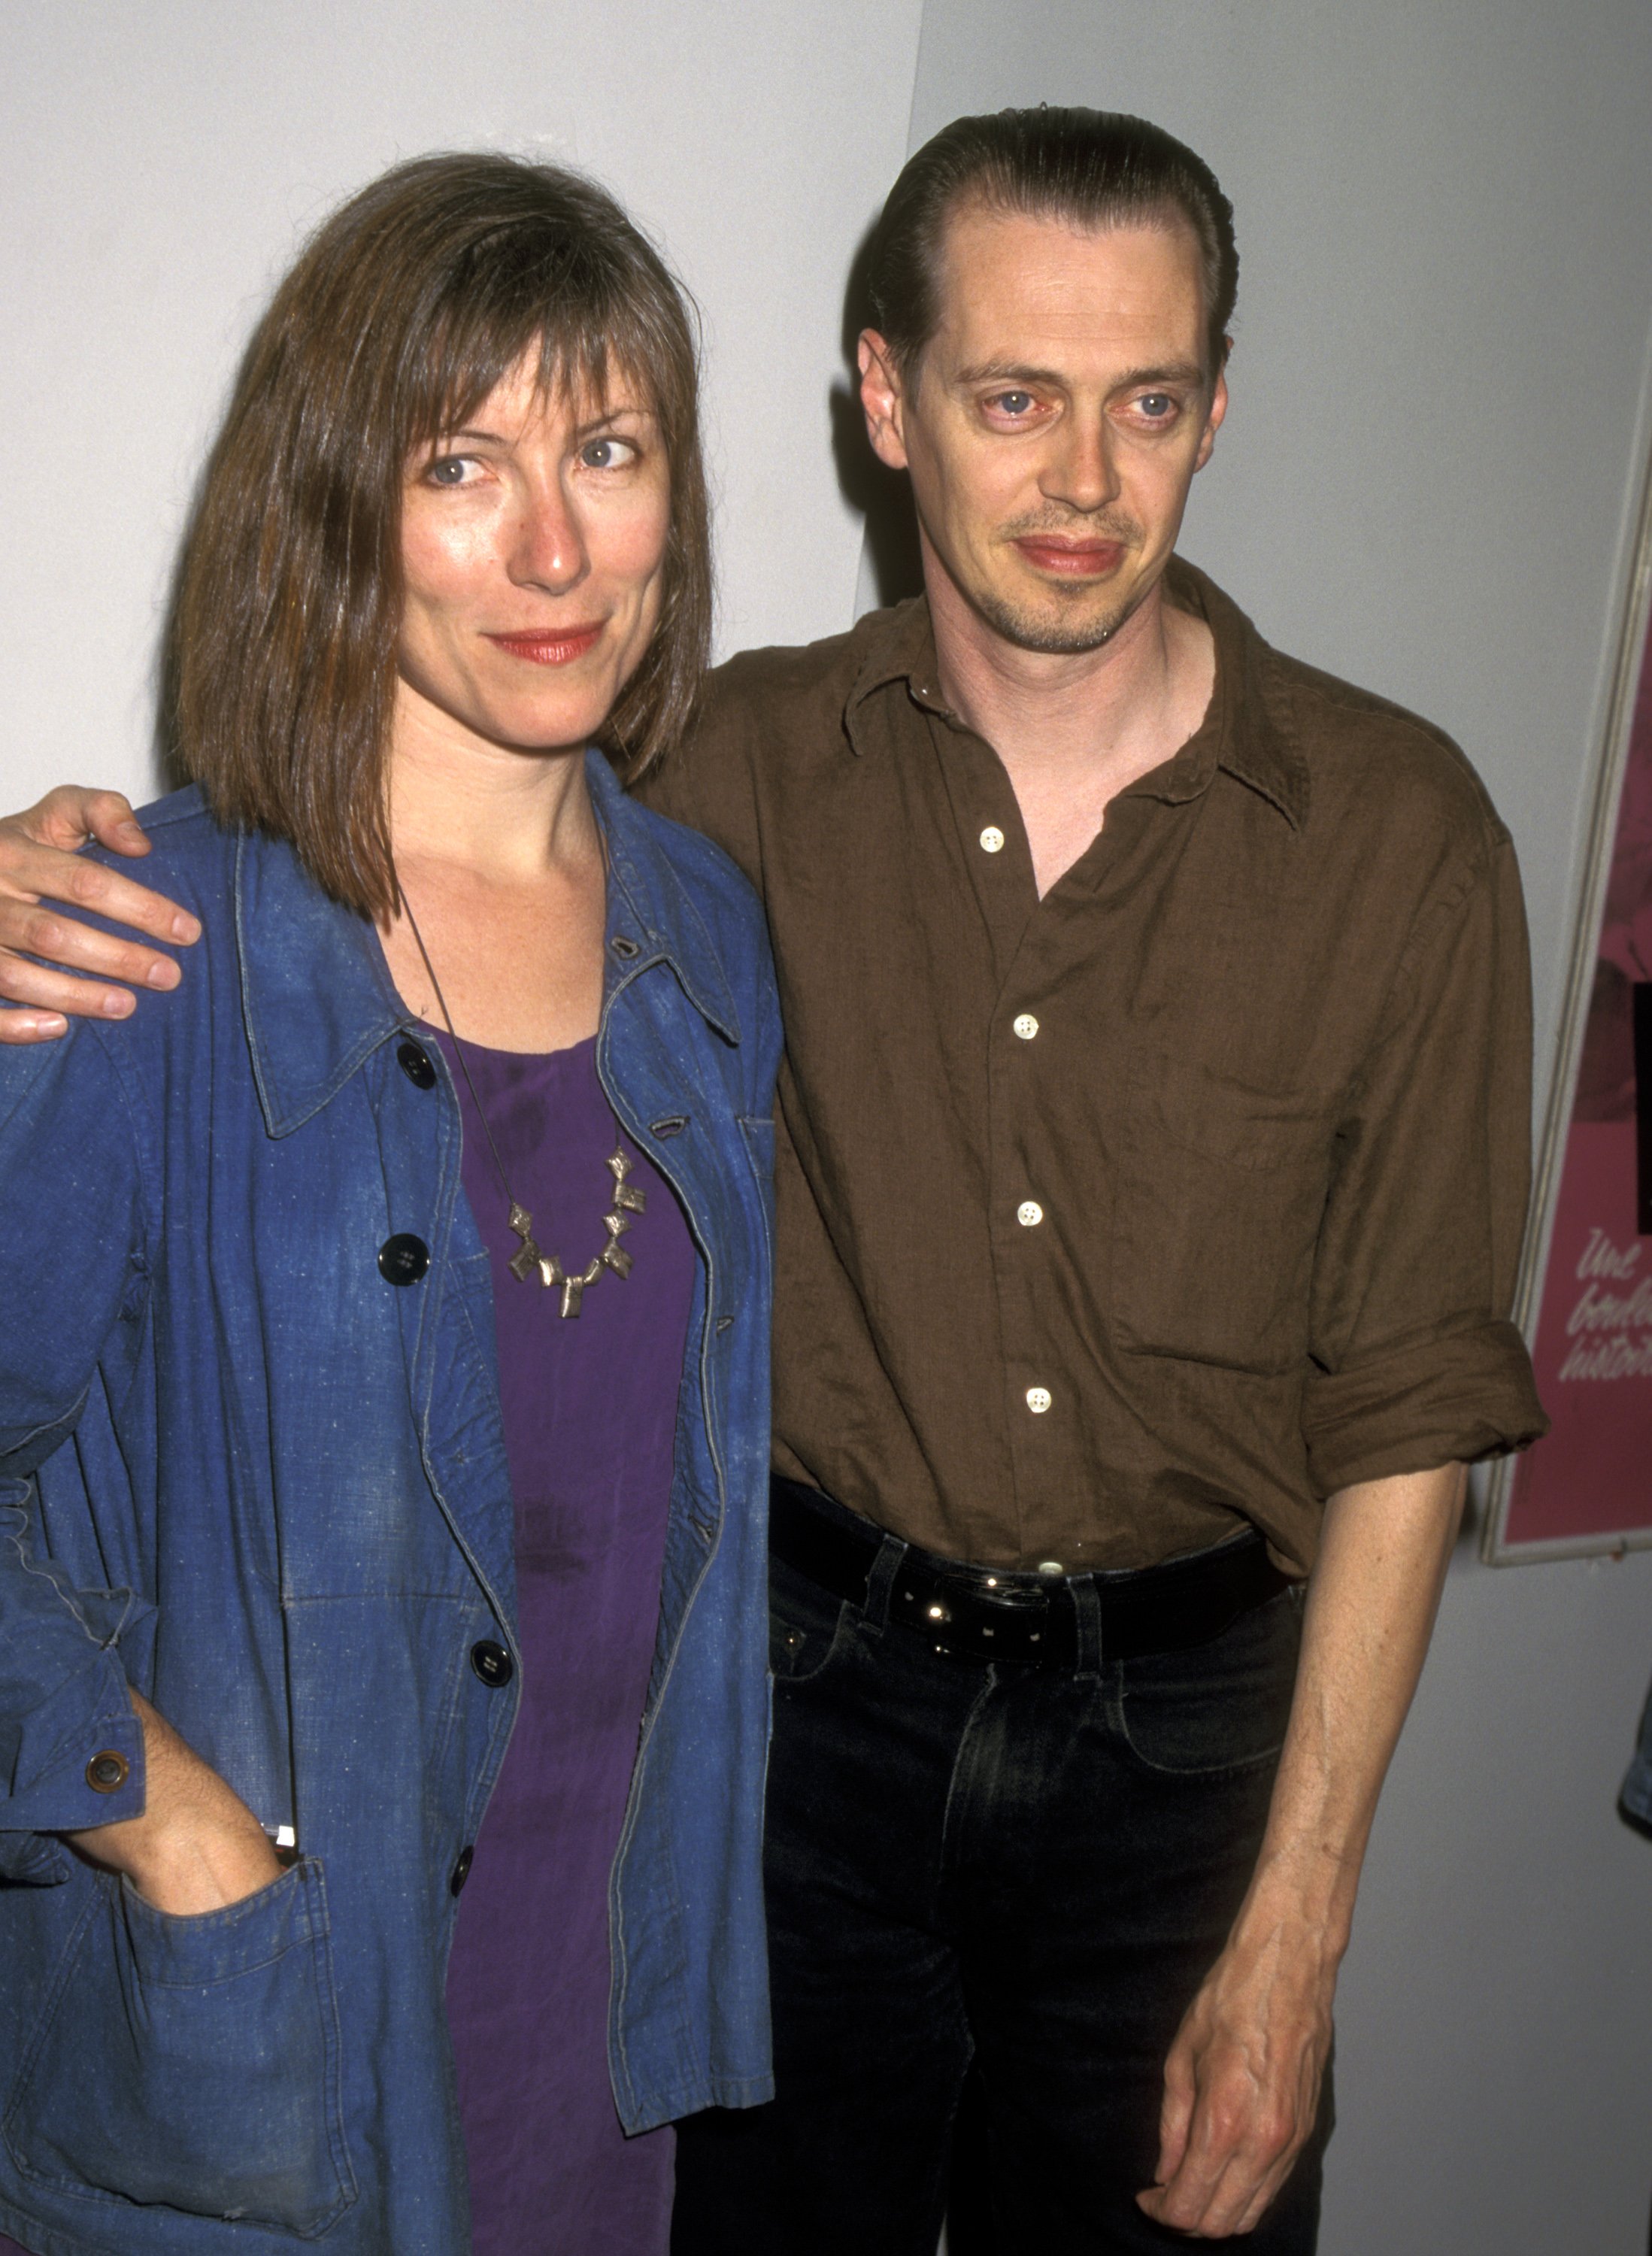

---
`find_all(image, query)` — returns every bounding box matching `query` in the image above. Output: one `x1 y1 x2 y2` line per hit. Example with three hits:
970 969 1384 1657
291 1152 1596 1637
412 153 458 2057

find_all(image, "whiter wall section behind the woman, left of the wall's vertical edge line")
0 0 919 805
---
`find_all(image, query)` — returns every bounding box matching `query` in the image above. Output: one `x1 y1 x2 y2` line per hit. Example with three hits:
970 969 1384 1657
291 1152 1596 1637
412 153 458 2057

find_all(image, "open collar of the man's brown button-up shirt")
844 557 1309 830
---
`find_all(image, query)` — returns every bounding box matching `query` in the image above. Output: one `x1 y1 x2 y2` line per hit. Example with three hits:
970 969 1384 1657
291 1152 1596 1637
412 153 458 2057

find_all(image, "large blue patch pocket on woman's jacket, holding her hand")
5 1857 356 2238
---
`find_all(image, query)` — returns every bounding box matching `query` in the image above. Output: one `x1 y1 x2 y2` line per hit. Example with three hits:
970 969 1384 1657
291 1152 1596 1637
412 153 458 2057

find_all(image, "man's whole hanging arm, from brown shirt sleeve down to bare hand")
1140 808 1546 2238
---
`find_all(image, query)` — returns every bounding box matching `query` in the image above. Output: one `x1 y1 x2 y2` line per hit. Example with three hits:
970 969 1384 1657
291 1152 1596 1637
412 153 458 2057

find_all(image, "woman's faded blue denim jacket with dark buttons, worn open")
0 754 778 2256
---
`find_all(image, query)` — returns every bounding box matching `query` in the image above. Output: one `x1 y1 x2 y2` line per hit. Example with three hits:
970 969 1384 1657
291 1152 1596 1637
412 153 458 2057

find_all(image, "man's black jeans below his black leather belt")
672 1507 1332 2256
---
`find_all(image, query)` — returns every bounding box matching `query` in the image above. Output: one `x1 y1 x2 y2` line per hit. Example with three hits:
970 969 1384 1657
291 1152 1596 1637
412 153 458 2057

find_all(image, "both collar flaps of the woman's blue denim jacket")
235 751 740 1137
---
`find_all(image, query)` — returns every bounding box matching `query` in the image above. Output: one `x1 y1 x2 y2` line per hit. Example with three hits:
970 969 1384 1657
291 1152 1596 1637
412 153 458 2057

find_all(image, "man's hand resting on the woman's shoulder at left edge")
0 785 201 1042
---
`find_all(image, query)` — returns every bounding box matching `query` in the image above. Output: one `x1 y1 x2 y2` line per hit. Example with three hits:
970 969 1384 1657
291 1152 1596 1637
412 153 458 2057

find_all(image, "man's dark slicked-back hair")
867 104 1239 379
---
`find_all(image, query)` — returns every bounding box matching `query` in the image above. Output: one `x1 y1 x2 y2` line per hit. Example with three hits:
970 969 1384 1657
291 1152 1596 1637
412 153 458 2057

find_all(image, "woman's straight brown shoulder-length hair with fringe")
169 156 711 918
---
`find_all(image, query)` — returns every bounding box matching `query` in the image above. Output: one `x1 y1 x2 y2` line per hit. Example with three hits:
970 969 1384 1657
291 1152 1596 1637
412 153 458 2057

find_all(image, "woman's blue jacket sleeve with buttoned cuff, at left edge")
0 1029 151 1879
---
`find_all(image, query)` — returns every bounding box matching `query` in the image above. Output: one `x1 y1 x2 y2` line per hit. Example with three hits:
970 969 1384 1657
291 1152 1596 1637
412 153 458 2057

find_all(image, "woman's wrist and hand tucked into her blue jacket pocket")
65 1692 282 1913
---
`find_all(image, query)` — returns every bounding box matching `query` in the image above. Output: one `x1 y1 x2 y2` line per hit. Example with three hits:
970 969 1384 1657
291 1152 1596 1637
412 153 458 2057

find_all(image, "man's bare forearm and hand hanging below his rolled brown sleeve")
1138 1464 1465 2238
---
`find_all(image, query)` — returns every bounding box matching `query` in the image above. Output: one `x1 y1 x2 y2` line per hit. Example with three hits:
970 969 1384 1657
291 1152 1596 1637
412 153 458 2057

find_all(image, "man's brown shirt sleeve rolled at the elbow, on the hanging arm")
1302 828 1548 1496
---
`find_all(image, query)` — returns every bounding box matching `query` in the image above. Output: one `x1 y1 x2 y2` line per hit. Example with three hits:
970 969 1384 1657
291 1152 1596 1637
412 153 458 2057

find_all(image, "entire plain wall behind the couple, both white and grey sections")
0 0 1652 2256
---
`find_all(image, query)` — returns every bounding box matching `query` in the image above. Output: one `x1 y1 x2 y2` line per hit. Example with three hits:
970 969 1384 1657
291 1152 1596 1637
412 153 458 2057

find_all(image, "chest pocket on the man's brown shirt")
1113 1051 1334 1374
